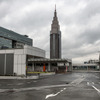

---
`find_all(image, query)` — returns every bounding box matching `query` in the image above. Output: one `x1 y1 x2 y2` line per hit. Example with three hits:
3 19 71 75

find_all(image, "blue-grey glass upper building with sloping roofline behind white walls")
0 27 32 49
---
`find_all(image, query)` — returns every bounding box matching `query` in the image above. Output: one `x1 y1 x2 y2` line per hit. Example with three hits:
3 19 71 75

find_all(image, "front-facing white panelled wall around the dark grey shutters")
0 49 26 75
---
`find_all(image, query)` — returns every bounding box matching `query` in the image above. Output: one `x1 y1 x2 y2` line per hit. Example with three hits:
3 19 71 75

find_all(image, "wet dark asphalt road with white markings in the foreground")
0 73 100 100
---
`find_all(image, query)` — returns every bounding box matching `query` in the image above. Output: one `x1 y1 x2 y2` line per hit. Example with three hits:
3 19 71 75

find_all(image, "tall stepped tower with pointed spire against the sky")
50 7 61 59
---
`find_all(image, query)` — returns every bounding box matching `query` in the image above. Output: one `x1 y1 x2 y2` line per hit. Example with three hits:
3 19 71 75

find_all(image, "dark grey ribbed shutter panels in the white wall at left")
0 54 14 75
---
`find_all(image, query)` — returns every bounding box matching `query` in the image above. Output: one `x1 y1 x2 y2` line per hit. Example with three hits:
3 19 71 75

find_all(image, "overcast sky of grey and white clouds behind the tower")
0 0 100 62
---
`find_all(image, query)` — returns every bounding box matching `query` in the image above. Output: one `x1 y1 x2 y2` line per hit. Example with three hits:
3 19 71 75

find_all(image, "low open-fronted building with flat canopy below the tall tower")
28 58 72 73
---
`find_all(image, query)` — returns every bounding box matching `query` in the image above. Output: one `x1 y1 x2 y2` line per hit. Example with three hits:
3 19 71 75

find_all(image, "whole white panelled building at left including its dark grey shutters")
0 45 45 75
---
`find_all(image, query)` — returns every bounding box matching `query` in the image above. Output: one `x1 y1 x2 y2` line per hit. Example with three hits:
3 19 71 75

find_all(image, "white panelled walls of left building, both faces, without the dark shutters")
0 46 45 75
